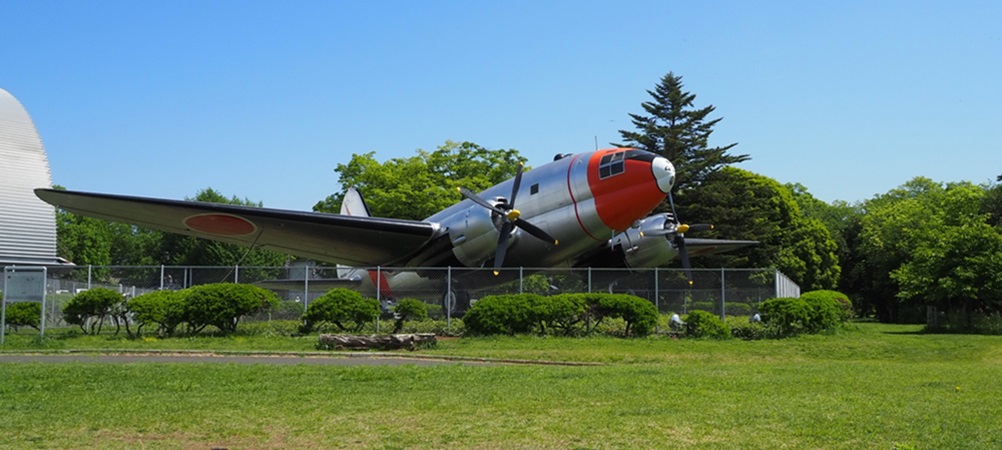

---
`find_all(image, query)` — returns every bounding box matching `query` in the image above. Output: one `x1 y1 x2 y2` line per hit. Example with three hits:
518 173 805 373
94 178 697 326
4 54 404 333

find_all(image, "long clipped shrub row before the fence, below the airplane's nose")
463 294 658 336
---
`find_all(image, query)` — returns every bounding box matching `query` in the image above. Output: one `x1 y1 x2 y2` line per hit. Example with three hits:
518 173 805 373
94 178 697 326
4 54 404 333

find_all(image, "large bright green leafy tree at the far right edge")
857 177 1002 322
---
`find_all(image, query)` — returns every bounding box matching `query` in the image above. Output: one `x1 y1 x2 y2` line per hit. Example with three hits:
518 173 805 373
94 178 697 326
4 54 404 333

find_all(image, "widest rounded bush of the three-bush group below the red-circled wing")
183 283 279 334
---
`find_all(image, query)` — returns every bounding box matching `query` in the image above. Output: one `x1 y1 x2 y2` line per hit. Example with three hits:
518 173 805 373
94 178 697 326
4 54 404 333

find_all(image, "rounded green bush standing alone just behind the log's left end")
302 288 380 333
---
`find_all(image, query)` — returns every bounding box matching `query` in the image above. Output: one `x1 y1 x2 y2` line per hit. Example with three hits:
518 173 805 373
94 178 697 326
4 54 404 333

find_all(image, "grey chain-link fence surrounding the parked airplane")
37 266 800 326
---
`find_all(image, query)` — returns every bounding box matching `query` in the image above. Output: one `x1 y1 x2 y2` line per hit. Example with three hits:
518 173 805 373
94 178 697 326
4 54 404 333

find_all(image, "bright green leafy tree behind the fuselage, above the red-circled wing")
314 140 525 220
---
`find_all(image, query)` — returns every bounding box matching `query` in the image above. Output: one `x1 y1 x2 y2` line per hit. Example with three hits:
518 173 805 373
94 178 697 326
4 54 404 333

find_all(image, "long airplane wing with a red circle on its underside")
35 188 440 266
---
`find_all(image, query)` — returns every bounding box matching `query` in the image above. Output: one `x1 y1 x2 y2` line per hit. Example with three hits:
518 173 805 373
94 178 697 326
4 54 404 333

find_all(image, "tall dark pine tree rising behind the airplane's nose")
619 72 750 191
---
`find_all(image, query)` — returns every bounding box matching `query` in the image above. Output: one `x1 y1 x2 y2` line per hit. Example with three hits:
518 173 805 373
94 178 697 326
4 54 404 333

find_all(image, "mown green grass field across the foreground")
0 324 1002 449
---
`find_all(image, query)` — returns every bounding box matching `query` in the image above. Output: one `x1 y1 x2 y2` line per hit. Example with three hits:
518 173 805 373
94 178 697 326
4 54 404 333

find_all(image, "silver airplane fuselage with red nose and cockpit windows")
426 148 674 268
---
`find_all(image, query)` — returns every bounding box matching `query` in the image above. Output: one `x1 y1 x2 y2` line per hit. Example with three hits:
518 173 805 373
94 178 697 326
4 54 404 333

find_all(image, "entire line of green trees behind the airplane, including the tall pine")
57 72 1002 326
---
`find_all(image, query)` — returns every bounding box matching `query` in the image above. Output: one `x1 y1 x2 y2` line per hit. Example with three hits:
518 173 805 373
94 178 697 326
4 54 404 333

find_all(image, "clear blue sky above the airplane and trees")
0 0 1002 209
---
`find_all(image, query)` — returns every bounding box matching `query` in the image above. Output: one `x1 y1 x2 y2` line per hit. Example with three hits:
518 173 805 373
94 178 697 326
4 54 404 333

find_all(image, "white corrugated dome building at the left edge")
0 89 68 268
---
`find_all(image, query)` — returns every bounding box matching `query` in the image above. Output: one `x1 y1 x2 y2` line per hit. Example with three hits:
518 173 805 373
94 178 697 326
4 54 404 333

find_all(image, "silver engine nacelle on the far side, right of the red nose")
609 213 678 268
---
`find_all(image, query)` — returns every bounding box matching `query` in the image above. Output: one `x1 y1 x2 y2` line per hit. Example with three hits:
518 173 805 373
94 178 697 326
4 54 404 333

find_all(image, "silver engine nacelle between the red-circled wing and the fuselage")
443 206 514 268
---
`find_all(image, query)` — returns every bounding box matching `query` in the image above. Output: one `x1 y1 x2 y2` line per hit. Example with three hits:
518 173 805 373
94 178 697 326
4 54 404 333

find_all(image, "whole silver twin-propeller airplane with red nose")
35 148 757 306
